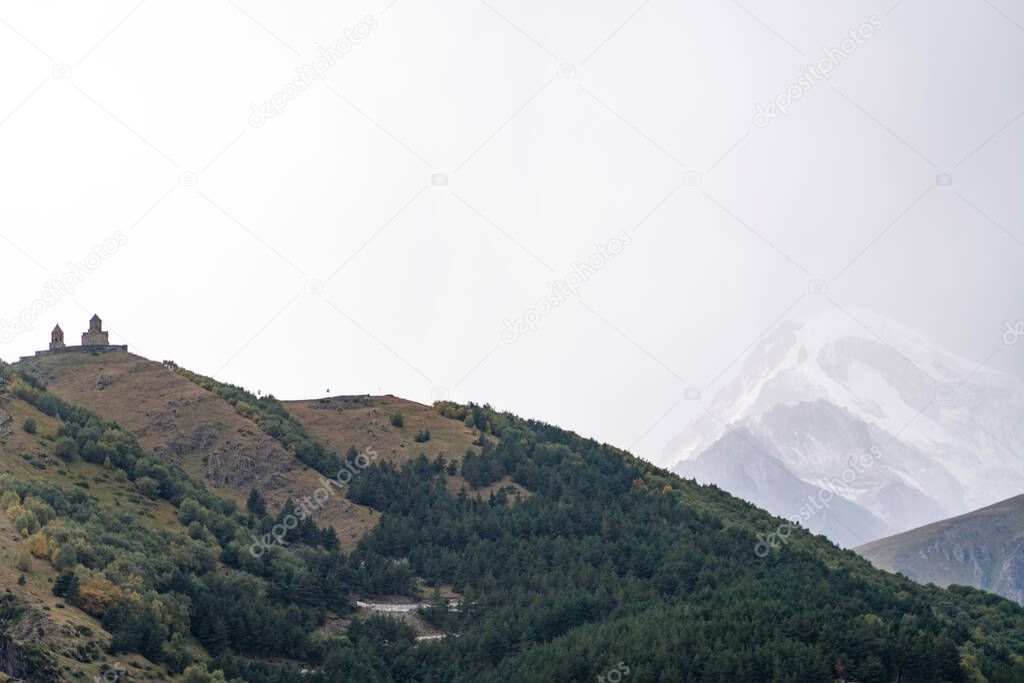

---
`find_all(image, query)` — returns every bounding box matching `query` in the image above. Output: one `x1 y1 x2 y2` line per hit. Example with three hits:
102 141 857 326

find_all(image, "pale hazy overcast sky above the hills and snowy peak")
0 0 1024 471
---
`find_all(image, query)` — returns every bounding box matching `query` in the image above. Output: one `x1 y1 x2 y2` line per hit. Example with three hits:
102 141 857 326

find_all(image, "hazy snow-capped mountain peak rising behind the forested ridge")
668 310 1024 545
